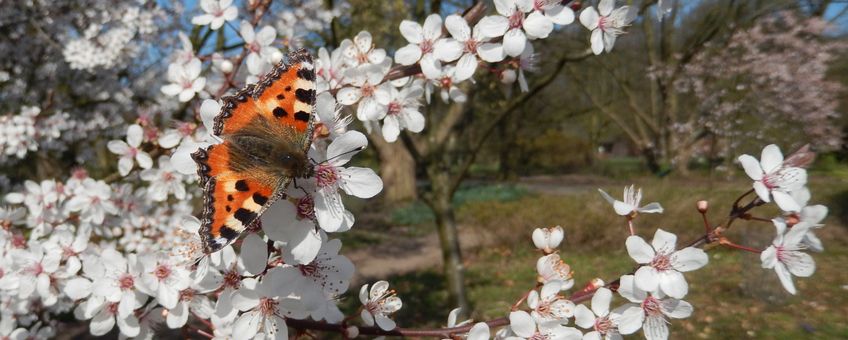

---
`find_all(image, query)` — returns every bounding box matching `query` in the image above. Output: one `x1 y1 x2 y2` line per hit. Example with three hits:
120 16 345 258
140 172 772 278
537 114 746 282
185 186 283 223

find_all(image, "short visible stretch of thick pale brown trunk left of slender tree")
371 137 417 204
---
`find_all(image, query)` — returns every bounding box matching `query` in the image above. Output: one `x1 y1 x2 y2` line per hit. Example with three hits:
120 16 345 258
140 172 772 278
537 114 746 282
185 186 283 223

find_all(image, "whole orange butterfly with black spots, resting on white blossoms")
191 50 315 254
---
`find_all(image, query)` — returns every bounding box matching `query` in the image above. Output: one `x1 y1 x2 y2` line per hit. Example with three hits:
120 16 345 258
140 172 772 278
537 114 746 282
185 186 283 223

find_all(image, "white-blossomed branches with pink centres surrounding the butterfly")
0 0 840 339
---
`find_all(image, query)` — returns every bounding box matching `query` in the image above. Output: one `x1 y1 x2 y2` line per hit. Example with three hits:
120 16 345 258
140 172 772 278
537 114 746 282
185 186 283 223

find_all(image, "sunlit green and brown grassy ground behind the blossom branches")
346 173 848 339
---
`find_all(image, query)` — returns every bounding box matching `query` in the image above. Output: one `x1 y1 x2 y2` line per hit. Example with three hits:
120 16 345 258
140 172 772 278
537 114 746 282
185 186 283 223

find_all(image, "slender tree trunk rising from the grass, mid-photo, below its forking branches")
425 164 471 316
